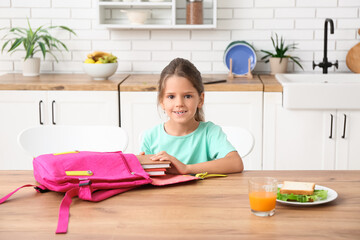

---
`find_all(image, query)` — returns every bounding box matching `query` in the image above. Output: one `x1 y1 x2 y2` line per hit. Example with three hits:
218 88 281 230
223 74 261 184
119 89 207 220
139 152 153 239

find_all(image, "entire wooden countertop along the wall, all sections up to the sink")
0 73 282 92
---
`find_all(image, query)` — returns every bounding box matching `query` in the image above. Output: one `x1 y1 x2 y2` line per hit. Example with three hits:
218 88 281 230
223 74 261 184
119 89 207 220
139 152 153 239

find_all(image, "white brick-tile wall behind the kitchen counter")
0 0 360 73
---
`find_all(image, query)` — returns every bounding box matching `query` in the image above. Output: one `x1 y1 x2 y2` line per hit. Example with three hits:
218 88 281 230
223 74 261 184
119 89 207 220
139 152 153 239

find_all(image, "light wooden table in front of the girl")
0 171 360 240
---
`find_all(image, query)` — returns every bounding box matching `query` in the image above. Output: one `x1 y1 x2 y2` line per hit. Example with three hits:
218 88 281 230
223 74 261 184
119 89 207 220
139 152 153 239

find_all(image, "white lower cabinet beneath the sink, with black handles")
263 92 360 170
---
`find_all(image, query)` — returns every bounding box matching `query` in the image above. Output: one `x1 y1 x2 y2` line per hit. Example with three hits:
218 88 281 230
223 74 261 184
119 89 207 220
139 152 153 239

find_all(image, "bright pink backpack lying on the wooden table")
0 151 152 233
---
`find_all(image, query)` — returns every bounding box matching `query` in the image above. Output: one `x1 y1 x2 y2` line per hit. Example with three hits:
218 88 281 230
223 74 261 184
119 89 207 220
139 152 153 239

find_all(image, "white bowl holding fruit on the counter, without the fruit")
83 63 118 80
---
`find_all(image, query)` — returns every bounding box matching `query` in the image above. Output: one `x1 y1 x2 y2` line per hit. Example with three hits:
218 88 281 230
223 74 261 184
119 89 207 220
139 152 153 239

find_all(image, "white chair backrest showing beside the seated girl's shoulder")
221 126 255 158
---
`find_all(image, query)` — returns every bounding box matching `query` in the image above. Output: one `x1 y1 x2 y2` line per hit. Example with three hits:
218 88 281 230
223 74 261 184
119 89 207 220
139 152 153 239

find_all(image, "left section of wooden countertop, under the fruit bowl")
0 73 128 91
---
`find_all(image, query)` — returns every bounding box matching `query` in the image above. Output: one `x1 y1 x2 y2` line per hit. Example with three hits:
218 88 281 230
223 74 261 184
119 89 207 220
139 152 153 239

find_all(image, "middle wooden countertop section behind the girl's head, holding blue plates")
120 74 263 92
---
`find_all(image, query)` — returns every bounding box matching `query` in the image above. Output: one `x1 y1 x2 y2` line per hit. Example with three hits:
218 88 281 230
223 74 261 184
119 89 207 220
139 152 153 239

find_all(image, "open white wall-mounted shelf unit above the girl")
98 0 217 29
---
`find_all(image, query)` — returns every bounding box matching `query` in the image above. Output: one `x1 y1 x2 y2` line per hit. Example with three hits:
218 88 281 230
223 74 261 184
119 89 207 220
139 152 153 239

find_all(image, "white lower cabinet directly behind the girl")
120 92 262 169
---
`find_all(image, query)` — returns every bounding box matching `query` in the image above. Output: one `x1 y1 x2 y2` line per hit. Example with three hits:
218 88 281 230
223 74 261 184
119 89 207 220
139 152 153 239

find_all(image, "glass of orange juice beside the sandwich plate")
249 177 277 217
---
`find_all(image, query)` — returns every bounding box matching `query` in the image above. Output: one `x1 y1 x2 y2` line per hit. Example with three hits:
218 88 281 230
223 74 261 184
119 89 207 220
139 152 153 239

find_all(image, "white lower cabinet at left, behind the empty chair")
0 91 119 170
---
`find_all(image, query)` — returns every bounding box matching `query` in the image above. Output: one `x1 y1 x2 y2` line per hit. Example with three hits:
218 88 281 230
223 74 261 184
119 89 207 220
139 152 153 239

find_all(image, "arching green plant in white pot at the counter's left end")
1 19 76 76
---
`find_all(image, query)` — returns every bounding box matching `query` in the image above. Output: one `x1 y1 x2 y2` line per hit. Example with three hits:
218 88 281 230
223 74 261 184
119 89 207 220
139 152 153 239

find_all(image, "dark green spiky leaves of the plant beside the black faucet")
261 33 304 70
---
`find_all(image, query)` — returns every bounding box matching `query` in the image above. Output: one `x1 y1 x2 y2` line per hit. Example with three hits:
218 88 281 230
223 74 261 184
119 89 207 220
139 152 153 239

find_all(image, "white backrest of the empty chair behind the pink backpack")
18 125 128 157
